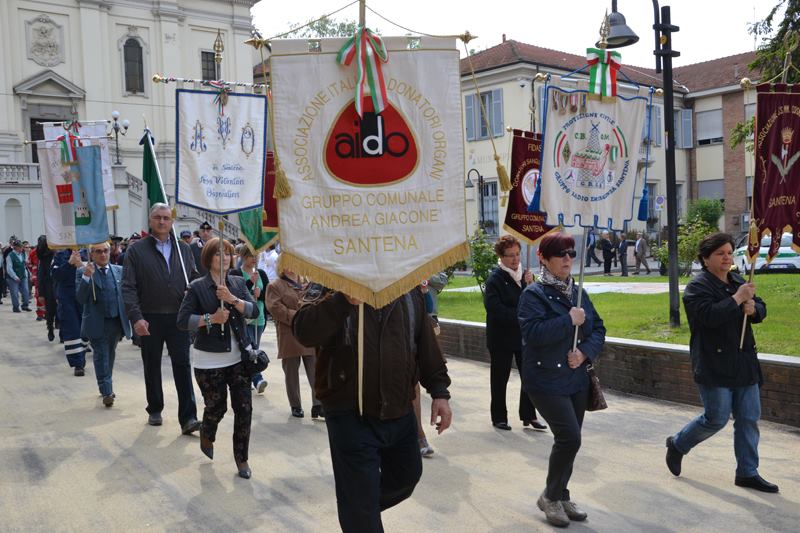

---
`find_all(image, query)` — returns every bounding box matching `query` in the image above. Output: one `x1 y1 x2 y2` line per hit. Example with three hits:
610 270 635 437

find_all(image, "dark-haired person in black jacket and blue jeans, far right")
666 233 778 492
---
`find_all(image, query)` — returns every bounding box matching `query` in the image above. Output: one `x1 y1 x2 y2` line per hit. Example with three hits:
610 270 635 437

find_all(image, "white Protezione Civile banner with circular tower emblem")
531 85 649 230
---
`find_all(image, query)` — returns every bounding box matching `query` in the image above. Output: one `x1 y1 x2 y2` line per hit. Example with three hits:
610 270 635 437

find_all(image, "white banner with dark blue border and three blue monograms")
175 90 267 215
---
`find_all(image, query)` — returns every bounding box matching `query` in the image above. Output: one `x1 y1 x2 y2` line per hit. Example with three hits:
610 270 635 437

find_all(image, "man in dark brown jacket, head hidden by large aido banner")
293 289 453 533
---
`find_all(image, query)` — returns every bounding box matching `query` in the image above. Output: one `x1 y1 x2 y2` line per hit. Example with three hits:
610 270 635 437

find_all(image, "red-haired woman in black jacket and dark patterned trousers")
177 237 258 479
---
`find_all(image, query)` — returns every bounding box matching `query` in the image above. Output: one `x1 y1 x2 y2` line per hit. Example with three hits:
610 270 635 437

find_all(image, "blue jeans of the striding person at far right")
674 384 761 477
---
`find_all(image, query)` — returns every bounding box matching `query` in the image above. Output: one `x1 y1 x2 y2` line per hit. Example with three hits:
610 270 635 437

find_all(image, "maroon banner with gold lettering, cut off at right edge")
748 83 800 262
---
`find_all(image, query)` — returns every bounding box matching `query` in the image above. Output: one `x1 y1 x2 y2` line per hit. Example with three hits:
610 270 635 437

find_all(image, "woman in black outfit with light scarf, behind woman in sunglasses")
483 235 547 431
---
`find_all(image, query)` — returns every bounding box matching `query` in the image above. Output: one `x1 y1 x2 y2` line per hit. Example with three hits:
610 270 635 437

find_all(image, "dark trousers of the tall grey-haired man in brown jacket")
139 314 197 425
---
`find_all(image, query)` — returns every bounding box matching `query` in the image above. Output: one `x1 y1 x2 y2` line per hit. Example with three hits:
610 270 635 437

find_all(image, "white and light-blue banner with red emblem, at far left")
38 142 109 248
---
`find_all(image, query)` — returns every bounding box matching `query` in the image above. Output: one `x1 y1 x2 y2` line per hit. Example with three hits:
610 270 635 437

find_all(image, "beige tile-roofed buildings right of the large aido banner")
461 36 755 236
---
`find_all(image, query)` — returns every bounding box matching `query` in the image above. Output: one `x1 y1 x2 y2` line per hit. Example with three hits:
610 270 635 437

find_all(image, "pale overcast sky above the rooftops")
252 0 777 68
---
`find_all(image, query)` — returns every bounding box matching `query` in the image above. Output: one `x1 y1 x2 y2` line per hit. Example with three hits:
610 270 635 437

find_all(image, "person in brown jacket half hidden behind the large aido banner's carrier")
267 270 325 419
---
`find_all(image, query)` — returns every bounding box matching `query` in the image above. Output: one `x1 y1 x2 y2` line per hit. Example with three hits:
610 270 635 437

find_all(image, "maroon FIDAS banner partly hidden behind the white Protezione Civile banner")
503 130 556 244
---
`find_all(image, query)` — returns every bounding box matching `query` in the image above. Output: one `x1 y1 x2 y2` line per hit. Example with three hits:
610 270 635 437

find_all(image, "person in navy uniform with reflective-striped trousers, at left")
51 249 88 376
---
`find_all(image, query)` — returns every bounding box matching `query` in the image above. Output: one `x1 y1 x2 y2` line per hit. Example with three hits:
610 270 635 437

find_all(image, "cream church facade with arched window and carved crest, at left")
0 0 257 241
